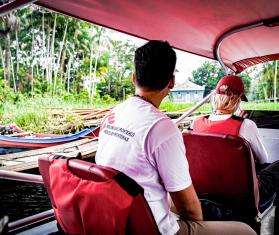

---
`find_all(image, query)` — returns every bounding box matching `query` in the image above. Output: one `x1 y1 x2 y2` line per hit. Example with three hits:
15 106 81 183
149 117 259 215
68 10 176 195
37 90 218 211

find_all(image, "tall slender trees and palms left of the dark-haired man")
0 5 135 102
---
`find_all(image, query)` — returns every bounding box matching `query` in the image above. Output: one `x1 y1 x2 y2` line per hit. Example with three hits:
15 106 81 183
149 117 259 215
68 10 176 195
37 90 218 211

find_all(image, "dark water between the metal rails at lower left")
0 180 51 221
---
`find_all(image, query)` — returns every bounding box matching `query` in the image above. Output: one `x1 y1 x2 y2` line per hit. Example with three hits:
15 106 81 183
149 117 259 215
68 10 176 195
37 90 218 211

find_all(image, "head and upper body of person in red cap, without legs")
193 75 268 164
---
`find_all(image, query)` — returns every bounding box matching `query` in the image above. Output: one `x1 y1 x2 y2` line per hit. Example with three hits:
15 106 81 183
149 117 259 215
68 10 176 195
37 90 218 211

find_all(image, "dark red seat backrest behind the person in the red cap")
183 132 259 215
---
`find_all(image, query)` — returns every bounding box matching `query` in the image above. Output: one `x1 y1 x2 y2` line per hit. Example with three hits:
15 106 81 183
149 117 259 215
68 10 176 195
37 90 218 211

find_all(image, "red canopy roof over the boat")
0 0 279 73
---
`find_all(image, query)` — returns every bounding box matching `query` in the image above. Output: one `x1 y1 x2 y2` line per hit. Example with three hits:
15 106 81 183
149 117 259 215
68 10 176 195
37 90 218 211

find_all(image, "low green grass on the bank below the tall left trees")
1 96 116 134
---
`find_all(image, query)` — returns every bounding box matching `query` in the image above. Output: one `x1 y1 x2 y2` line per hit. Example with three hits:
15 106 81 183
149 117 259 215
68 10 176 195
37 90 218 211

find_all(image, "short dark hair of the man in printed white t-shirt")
134 40 176 90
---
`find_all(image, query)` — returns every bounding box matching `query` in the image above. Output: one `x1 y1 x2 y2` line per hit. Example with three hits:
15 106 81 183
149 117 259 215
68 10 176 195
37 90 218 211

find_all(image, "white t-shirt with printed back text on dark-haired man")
96 97 192 234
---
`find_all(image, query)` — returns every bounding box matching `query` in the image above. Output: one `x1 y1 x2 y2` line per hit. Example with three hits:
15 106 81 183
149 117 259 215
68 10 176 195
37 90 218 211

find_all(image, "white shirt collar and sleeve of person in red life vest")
208 114 268 164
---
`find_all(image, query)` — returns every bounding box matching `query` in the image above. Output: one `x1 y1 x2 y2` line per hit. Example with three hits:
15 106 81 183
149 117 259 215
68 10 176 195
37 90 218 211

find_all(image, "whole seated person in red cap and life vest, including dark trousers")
193 75 279 213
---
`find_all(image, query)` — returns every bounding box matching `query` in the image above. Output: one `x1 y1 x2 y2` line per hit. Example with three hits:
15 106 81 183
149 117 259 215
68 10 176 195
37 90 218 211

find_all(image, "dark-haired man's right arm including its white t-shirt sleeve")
146 120 203 220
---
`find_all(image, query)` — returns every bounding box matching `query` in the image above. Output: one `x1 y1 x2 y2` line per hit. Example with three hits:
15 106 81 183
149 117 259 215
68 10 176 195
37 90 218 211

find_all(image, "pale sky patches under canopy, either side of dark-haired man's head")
112 31 209 83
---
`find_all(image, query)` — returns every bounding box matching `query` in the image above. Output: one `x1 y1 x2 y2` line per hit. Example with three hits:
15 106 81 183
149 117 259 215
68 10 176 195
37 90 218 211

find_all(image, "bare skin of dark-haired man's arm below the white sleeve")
170 184 203 221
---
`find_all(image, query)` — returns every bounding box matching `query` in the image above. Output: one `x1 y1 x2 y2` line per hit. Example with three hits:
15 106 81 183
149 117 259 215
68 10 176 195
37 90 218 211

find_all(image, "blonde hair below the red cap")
211 93 241 114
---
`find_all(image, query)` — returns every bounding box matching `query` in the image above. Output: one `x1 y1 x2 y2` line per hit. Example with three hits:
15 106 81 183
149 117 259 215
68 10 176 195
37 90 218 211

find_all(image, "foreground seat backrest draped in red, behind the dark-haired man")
39 155 159 234
